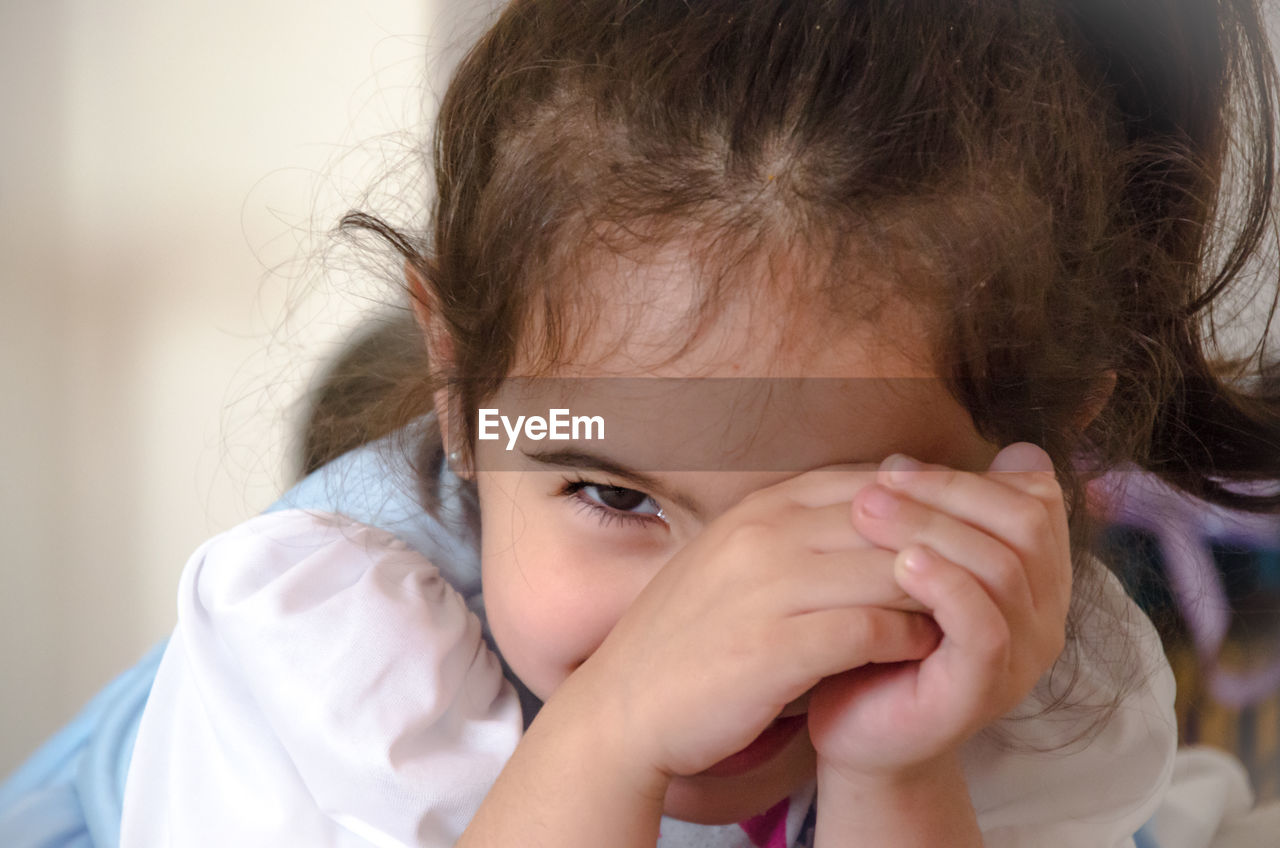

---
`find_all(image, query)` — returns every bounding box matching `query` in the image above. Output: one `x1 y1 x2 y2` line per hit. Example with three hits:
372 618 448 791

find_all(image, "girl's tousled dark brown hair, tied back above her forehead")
322 0 1280 753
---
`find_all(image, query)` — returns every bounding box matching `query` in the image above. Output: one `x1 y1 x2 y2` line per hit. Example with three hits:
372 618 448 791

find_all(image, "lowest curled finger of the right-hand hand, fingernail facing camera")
897 546 1012 713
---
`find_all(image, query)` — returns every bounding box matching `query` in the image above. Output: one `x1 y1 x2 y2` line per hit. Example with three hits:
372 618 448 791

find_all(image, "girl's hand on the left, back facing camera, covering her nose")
560 465 938 778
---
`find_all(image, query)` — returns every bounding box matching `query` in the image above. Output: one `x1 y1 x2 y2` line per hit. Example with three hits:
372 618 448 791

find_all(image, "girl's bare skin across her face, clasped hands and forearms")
420 252 1090 845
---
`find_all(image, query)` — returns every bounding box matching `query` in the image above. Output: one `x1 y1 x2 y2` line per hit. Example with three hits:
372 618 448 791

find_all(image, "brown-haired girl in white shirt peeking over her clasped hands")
6 0 1280 848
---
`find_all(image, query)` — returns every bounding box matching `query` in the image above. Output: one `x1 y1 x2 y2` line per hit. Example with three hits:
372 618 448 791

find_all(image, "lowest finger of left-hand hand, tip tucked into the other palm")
777 607 942 687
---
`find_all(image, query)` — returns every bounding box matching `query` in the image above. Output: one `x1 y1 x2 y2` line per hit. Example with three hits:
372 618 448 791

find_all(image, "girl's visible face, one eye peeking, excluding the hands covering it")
458 249 998 824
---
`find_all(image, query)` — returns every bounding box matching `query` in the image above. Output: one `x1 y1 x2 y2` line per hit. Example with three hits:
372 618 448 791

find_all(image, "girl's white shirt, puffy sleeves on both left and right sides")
122 448 1228 848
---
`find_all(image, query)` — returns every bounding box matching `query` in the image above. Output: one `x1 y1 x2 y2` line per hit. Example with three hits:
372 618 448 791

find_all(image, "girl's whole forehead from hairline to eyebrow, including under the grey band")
480 239 995 491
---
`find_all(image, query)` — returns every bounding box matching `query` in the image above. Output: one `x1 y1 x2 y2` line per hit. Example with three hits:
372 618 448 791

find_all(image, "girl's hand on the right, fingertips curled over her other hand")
809 442 1071 779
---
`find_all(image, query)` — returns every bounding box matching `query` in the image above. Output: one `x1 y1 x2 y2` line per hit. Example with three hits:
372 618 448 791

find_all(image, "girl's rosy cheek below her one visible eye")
481 525 644 701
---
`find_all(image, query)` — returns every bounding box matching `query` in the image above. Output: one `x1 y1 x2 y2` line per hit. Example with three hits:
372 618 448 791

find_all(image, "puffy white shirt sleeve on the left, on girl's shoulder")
120 510 522 848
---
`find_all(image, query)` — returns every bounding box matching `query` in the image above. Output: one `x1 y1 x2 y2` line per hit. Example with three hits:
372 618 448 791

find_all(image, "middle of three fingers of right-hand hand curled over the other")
855 485 1039 621
